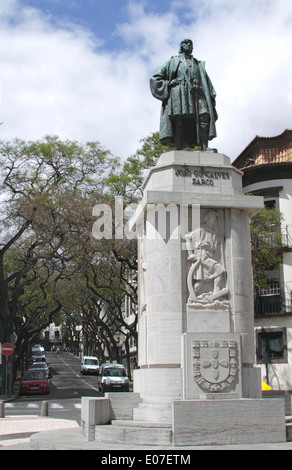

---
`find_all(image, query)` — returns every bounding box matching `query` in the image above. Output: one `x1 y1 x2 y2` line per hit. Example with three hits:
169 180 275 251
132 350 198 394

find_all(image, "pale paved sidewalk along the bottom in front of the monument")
0 416 292 453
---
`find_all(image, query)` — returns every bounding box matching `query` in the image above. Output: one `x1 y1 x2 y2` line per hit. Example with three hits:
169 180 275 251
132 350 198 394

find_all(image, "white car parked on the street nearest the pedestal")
97 364 129 393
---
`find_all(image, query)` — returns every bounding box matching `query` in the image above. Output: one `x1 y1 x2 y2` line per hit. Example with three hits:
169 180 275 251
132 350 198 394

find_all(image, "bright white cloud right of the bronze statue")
179 0 292 159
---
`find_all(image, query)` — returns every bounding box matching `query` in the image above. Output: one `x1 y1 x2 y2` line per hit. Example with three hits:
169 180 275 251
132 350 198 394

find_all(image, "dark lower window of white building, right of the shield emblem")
256 328 288 364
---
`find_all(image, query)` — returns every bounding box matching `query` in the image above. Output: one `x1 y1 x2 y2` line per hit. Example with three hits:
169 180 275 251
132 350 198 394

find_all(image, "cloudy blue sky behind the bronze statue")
0 0 292 161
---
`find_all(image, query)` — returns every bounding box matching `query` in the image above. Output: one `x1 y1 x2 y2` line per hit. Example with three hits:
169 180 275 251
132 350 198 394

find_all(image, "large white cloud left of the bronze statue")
0 1 151 157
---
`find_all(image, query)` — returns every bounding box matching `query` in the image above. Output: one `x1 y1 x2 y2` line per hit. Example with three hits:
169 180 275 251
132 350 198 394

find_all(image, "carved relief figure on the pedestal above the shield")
186 211 229 307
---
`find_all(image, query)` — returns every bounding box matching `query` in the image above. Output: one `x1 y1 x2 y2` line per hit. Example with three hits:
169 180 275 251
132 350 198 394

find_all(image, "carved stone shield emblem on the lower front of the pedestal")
193 340 238 393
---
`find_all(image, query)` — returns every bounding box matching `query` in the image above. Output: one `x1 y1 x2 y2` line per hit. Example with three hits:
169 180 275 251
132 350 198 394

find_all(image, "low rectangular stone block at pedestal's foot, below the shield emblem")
173 398 286 446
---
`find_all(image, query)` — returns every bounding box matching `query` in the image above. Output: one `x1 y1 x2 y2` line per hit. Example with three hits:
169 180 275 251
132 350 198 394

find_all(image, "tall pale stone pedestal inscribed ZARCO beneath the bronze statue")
128 151 284 445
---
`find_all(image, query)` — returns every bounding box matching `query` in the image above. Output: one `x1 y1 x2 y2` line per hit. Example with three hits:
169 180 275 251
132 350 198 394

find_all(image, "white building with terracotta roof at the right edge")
233 129 292 390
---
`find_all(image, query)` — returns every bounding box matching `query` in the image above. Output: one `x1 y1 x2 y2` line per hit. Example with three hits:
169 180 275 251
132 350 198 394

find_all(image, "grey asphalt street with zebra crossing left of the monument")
5 352 102 425
